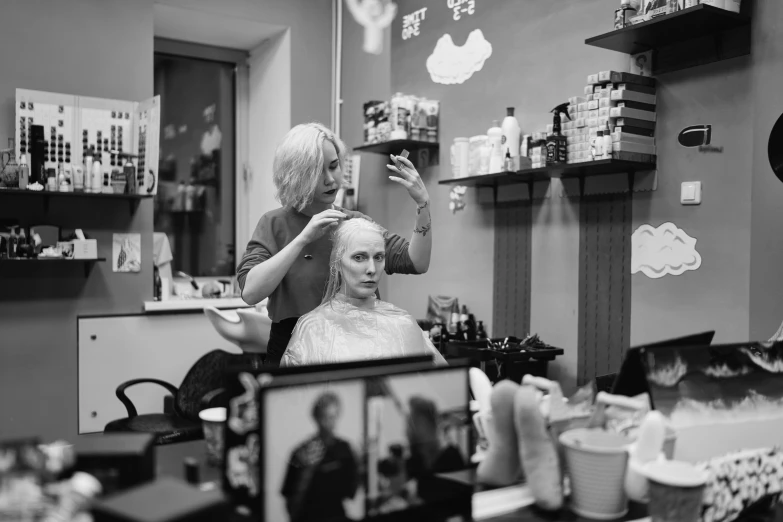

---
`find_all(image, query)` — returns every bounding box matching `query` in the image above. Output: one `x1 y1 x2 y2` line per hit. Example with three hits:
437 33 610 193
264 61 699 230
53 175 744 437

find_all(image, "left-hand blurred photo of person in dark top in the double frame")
263 381 364 522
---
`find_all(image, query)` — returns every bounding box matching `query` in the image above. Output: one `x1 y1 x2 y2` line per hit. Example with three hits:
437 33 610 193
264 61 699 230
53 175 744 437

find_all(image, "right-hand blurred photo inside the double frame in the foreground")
367 369 470 514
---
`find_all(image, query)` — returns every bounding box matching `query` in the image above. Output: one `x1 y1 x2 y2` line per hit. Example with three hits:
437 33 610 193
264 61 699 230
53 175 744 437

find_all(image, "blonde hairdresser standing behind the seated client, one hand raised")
237 123 432 366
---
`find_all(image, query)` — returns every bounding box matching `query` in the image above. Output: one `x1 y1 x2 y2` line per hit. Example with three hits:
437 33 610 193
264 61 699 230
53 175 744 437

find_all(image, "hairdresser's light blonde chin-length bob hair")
272 122 346 212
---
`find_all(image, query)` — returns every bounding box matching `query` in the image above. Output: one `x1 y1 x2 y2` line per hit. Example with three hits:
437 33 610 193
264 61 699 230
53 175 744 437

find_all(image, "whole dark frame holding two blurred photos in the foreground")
223 359 472 522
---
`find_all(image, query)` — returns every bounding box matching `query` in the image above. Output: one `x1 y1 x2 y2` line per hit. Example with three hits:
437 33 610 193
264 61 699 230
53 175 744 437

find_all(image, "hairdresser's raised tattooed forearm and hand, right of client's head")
386 156 432 274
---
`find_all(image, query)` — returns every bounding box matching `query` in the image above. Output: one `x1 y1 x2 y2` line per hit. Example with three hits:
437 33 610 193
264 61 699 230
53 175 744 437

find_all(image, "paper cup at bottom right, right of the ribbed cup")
642 460 708 522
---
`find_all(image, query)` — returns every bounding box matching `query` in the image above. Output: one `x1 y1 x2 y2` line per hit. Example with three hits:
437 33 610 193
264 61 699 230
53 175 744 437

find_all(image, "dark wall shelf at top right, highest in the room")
585 4 751 74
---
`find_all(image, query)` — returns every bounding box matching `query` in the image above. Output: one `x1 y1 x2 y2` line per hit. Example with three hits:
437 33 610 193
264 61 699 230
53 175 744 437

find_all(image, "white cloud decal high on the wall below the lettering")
427 29 492 85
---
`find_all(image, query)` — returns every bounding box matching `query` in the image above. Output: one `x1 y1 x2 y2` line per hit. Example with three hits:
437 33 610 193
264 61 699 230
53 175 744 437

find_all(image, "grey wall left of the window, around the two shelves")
0 0 153 439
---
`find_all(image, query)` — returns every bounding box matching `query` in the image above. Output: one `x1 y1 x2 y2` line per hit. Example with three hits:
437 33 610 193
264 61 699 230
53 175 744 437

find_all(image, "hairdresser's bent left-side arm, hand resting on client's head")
237 210 345 305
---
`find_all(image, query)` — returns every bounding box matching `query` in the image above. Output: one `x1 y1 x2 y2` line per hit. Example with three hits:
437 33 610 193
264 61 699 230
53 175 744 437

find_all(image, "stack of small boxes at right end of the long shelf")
562 71 656 163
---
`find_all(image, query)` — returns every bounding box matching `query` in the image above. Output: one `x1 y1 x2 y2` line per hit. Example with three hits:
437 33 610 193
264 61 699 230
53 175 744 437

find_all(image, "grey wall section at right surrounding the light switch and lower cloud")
631 57 752 344
